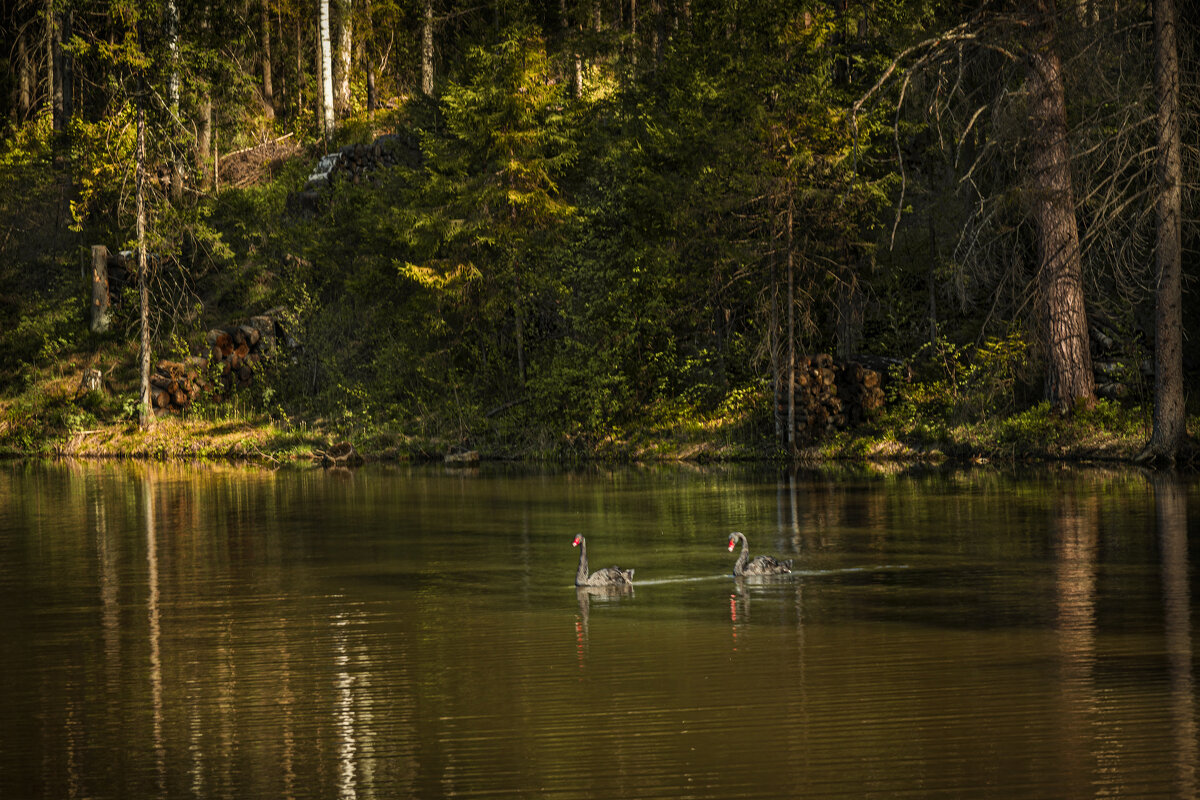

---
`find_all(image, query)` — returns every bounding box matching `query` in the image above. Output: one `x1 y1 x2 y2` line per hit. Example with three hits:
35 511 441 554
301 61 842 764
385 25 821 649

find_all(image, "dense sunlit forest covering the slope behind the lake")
0 0 1200 462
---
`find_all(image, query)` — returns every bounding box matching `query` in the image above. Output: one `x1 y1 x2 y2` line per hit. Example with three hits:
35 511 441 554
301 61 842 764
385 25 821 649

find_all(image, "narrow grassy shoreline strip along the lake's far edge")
0 419 1180 469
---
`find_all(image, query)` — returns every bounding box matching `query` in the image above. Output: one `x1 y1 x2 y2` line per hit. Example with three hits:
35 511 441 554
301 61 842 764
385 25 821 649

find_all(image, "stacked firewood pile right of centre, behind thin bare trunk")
779 353 883 441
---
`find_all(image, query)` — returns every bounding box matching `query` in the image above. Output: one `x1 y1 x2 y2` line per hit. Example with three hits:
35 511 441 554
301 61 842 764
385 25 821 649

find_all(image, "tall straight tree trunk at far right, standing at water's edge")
1139 0 1187 462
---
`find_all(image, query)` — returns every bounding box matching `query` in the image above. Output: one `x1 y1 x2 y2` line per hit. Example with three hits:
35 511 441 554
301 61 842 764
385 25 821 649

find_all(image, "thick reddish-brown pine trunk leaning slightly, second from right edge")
1028 0 1096 411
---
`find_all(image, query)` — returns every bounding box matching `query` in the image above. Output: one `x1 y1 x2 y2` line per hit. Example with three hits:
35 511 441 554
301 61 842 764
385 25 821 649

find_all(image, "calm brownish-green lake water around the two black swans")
0 463 1200 800
